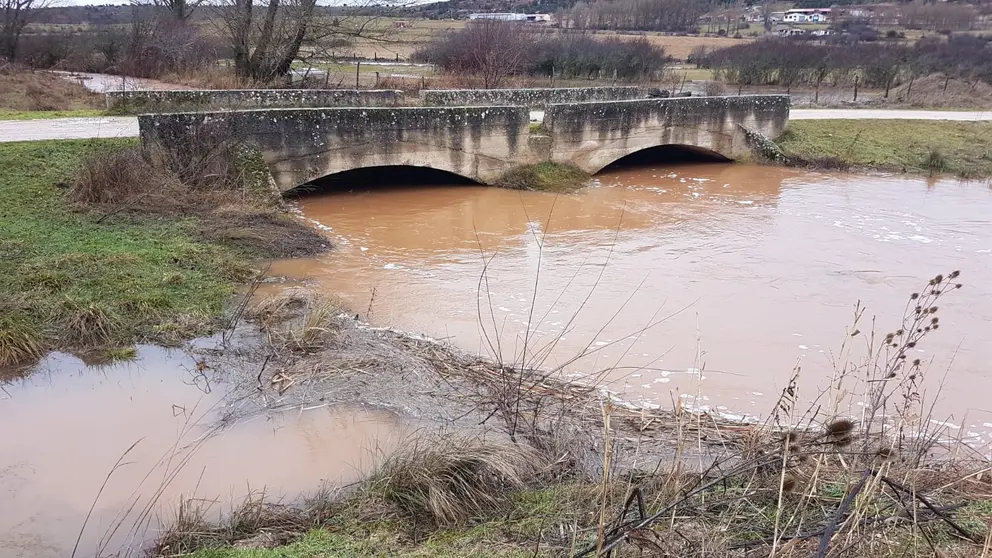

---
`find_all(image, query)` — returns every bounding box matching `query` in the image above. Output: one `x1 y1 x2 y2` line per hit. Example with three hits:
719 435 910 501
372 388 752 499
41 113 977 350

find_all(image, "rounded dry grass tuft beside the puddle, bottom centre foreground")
366 436 540 526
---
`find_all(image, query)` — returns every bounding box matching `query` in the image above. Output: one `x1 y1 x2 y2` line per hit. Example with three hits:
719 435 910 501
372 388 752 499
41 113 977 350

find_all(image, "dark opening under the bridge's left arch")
283 165 479 197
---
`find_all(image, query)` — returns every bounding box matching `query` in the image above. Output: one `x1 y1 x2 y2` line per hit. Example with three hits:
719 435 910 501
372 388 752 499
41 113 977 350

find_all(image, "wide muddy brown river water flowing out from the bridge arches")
273 164 992 445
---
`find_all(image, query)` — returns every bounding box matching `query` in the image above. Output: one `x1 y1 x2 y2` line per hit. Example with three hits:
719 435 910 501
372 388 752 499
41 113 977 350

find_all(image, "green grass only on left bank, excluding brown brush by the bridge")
0 140 252 366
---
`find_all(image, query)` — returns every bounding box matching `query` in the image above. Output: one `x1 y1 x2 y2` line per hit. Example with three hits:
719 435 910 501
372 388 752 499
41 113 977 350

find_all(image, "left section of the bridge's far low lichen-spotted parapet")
106 89 403 113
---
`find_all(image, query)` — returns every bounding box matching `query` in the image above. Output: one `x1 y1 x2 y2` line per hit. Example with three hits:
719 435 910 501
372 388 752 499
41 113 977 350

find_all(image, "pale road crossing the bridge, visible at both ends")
0 109 992 142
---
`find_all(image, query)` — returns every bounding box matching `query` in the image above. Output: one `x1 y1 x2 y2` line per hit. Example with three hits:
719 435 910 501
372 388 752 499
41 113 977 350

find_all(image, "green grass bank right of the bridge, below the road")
776 120 992 178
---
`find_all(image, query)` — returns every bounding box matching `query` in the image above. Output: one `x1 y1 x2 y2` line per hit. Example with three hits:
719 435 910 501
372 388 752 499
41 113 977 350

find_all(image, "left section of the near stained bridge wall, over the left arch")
138 106 541 191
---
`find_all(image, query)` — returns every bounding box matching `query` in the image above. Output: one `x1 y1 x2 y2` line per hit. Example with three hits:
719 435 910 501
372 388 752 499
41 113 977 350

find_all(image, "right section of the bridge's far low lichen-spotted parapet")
420 86 667 107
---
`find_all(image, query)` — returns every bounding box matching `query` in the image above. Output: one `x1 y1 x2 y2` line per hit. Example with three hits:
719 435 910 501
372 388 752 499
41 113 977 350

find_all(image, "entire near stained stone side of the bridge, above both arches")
139 95 789 191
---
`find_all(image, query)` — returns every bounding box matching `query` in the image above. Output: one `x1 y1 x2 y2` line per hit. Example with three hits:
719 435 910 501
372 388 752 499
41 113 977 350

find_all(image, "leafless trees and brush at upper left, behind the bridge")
8 0 396 83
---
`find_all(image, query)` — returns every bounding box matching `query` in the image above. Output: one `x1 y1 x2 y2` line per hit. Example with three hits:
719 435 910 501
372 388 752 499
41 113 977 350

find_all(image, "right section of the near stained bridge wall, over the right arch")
544 95 789 173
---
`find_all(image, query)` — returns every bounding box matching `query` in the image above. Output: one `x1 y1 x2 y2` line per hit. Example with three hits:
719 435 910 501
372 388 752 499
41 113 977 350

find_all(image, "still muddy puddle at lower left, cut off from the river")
0 347 412 558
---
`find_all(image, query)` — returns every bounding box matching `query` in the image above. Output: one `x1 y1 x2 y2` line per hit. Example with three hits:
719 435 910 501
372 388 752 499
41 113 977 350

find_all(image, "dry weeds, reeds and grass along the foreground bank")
147 278 992 558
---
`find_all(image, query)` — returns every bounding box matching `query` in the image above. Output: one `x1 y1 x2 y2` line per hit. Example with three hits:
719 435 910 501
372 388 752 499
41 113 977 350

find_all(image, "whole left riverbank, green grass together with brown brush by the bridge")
0 140 326 374
